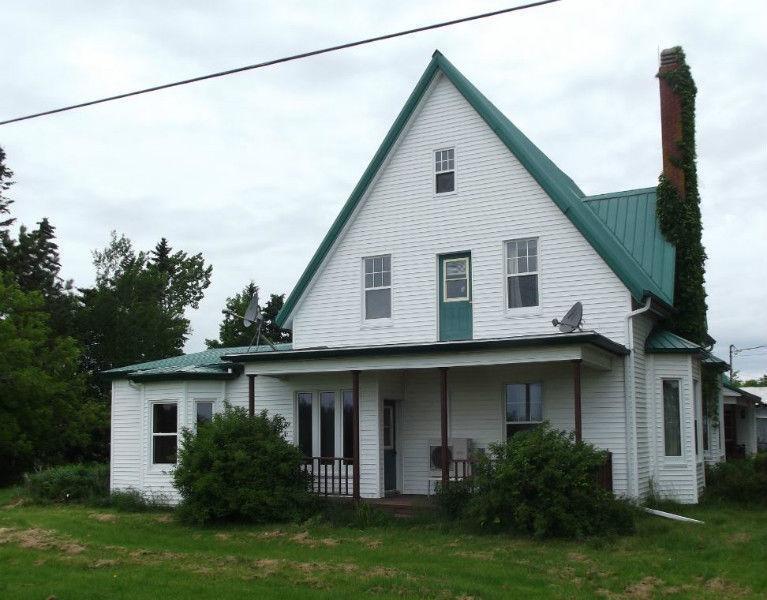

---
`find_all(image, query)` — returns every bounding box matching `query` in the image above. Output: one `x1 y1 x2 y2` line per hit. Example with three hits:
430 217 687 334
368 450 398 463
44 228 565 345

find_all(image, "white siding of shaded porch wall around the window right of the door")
397 363 626 494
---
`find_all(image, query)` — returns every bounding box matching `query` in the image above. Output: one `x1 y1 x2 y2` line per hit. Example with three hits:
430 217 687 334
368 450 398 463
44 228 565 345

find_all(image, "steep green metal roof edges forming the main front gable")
276 51 673 326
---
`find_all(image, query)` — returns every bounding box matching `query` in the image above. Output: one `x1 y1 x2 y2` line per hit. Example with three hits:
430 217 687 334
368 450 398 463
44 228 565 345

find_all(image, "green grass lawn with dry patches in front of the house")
0 490 767 600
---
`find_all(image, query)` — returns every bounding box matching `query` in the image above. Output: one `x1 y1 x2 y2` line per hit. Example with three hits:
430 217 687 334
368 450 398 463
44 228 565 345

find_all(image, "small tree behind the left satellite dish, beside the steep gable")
205 281 291 348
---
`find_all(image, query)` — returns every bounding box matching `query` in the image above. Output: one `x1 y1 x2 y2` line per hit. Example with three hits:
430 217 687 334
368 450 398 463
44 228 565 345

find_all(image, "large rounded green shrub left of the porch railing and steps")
173 407 317 523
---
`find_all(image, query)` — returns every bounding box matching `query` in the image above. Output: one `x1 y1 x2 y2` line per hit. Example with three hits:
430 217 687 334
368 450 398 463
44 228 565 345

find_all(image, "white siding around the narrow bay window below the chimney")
650 354 698 504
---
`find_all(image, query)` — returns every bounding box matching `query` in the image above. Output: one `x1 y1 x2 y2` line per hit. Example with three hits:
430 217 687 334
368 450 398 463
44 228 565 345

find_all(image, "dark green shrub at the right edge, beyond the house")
703 454 767 504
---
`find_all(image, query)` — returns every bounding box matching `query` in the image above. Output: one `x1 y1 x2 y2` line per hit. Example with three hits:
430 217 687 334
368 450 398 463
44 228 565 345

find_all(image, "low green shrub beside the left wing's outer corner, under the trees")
24 464 109 504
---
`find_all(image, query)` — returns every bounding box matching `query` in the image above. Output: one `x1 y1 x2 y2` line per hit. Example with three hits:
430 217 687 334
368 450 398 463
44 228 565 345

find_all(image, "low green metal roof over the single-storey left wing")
102 344 293 379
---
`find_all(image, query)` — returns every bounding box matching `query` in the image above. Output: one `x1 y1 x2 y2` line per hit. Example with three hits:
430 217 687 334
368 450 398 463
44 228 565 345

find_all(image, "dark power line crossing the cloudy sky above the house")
0 0 560 125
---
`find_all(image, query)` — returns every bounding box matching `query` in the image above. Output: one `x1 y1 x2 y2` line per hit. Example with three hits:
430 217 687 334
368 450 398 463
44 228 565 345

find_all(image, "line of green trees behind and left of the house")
0 148 291 485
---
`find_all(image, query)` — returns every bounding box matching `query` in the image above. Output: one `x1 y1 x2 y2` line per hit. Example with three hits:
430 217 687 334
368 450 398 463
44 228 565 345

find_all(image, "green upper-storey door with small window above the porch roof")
439 252 472 342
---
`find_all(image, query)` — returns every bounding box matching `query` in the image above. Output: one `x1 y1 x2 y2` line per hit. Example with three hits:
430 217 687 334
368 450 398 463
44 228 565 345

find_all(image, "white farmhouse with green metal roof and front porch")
108 52 726 503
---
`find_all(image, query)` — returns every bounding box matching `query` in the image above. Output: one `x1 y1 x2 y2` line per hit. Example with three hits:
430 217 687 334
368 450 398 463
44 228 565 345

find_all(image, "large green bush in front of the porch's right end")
465 425 634 537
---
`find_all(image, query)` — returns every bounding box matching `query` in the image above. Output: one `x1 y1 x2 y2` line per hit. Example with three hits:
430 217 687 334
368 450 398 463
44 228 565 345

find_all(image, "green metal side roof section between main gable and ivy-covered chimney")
583 188 676 299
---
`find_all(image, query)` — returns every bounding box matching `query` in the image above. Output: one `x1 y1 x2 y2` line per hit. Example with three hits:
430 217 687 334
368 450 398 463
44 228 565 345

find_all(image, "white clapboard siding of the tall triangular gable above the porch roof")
293 72 630 348
